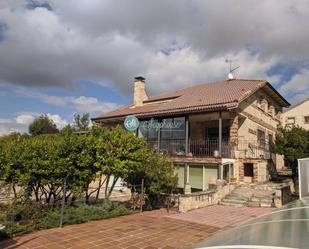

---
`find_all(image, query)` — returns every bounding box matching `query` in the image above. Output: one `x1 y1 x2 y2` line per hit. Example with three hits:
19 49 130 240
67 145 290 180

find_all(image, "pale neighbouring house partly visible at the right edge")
281 98 309 131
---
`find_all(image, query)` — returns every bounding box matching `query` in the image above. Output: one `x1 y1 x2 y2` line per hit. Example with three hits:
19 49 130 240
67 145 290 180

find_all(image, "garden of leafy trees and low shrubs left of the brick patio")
0 116 177 236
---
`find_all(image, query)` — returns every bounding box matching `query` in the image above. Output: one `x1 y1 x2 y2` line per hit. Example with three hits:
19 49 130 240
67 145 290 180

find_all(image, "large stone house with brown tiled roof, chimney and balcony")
92 77 289 193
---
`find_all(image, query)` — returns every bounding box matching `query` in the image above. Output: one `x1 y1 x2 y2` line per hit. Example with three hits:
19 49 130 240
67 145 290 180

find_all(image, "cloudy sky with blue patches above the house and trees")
0 0 309 135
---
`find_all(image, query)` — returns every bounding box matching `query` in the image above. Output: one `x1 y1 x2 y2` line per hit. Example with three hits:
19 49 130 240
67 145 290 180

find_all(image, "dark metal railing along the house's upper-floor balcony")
148 139 271 159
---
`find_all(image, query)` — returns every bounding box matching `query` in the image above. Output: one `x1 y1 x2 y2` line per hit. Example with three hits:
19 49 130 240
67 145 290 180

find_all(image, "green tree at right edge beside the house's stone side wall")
273 126 309 176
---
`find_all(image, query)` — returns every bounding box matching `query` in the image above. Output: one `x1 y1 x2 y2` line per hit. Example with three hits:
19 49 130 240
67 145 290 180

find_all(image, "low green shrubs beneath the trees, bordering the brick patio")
0 202 133 237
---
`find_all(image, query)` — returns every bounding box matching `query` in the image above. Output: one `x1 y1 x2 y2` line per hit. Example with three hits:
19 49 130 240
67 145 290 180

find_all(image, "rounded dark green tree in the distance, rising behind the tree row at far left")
29 114 59 136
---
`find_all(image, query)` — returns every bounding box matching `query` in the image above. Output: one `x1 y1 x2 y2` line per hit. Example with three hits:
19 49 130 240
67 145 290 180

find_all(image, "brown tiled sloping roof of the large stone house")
93 79 289 120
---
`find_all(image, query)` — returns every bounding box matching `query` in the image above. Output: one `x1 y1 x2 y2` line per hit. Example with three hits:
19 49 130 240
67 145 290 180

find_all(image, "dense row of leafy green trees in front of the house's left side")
0 126 176 206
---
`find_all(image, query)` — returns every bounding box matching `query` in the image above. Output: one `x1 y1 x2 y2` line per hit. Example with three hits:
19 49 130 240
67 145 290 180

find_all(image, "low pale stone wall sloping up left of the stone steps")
178 183 236 213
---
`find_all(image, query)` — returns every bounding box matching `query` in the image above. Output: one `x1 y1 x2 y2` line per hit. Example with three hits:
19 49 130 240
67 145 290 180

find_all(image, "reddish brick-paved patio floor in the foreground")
0 206 272 249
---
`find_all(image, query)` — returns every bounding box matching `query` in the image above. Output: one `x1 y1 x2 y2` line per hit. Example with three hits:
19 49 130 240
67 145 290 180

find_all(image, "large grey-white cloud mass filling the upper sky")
0 0 309 98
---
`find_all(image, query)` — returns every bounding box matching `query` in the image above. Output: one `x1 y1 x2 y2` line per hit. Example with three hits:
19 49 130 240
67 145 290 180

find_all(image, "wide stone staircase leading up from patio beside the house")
220 184 275 207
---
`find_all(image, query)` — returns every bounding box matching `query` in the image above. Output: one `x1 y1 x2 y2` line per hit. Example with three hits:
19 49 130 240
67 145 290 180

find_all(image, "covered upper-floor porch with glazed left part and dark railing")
138 112 238 158
